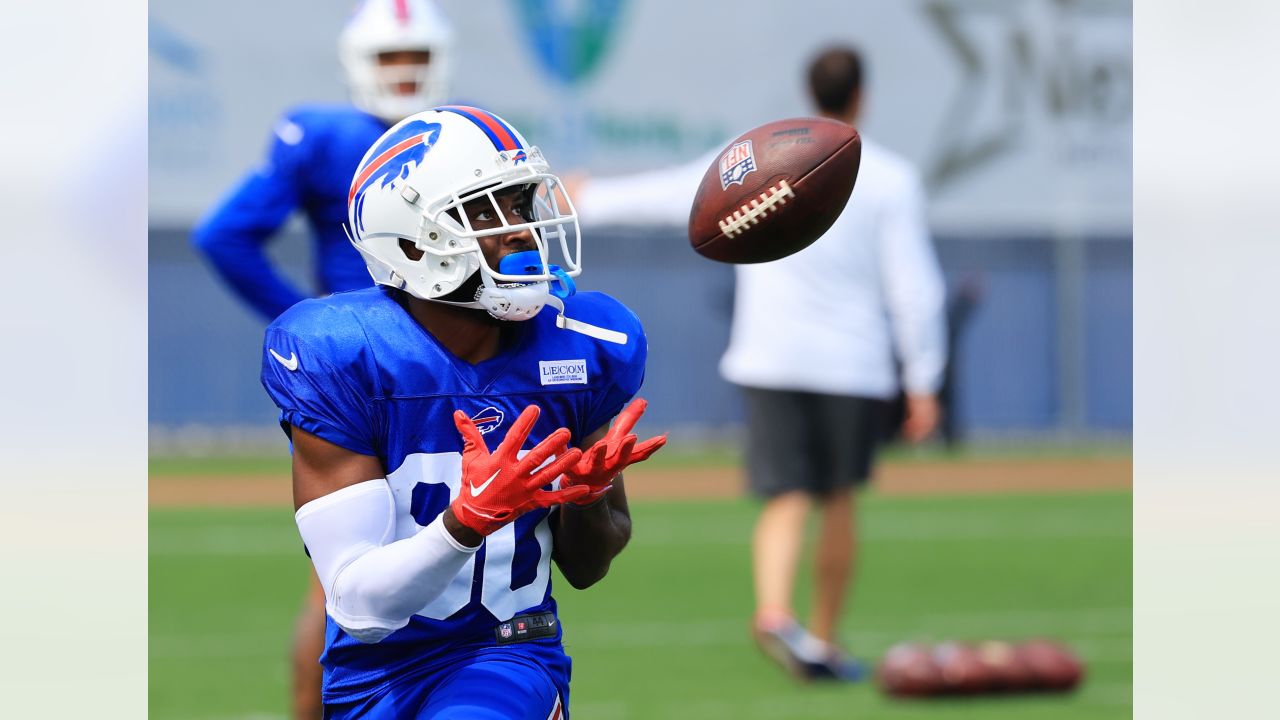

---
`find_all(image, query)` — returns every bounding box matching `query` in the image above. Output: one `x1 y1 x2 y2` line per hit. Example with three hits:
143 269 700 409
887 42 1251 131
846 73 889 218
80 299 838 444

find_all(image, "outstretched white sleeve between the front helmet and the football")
572 150 719 225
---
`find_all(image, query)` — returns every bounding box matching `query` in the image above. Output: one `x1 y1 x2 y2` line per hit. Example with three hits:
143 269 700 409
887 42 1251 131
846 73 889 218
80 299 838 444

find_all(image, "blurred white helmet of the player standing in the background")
338 0 453 123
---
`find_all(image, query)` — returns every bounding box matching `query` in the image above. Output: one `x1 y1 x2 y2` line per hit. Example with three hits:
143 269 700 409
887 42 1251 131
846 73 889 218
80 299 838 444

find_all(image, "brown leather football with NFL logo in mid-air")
689 118 863 263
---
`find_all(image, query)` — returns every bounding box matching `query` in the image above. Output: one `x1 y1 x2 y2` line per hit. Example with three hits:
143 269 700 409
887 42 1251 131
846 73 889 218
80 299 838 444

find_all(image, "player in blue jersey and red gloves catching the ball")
262 106 666 720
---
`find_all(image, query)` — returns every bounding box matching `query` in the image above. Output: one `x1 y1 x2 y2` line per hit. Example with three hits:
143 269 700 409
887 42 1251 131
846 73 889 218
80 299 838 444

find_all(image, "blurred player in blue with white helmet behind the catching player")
192 0 453 720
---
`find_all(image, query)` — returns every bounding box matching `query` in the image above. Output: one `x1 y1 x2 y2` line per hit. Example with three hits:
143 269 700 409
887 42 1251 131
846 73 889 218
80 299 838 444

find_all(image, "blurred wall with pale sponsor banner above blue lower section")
148 0 1133 450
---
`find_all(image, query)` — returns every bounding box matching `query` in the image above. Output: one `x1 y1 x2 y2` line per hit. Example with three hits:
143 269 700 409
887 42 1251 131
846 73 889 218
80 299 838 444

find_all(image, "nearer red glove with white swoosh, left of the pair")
451 405 591 536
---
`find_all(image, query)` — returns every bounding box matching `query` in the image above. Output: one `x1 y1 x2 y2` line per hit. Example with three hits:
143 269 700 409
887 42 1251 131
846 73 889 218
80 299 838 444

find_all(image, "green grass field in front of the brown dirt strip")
150 484 1132 720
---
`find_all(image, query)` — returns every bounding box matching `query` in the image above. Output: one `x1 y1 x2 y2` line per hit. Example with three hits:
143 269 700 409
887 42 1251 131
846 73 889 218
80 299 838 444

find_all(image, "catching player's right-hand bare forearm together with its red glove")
552 398 667 589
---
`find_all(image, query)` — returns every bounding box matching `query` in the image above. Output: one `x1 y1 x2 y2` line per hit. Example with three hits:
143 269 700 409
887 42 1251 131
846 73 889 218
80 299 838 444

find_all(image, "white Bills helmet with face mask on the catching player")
347 105 626 343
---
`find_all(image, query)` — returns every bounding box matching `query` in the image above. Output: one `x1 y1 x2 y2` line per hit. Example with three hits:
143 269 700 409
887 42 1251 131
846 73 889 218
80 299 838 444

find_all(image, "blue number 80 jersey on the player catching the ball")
262 286 646 702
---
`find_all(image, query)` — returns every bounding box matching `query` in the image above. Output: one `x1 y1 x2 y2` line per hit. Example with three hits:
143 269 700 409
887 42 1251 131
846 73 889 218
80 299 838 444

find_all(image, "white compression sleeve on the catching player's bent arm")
294 478 479 643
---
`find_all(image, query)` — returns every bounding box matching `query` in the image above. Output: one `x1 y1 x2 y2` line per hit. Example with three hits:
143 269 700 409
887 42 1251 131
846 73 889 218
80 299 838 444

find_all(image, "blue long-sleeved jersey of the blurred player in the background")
192 105 390 319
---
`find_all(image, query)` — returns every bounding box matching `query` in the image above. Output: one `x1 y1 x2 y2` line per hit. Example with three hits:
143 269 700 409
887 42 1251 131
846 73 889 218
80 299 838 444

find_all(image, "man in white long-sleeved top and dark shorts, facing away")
573 46 946 680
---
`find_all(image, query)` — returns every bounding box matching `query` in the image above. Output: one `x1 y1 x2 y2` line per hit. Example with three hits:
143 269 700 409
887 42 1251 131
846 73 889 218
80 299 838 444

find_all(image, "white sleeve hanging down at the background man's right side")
881 169 947 393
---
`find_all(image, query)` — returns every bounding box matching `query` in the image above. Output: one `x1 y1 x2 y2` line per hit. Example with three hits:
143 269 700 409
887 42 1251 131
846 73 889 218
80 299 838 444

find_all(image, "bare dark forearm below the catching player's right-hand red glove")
556 489 631 589
